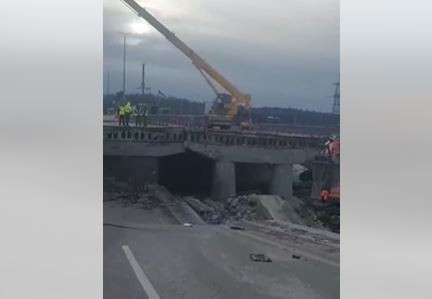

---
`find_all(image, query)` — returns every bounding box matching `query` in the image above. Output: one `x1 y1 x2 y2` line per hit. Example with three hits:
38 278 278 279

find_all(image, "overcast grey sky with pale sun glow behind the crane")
104 0 339 111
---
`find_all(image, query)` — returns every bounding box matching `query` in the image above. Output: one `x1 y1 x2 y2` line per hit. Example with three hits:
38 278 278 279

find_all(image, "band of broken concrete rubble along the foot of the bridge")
103 179 340 233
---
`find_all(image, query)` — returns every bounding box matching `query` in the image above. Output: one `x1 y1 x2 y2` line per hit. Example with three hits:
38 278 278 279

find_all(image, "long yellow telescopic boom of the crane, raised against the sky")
123 0 251 116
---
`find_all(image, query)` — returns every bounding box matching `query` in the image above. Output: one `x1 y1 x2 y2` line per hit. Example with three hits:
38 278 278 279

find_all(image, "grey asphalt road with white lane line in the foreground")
104 207 339 299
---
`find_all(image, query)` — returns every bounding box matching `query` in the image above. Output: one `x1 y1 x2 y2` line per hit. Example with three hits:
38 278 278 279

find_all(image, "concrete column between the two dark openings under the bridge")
212 160 236 200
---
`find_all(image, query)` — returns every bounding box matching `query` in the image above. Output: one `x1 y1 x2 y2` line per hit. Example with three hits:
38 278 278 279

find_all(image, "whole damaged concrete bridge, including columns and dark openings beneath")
103 113 337 200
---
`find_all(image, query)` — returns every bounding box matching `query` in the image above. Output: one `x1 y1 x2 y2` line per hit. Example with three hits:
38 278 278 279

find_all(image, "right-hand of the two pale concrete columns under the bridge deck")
270 164 293 199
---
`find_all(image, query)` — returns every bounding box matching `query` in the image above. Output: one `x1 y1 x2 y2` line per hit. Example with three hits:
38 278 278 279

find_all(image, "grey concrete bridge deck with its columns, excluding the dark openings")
103 125 323 199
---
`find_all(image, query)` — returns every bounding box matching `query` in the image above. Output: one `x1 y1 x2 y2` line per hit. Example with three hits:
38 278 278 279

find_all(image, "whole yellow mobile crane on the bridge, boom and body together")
122 0 252 129
